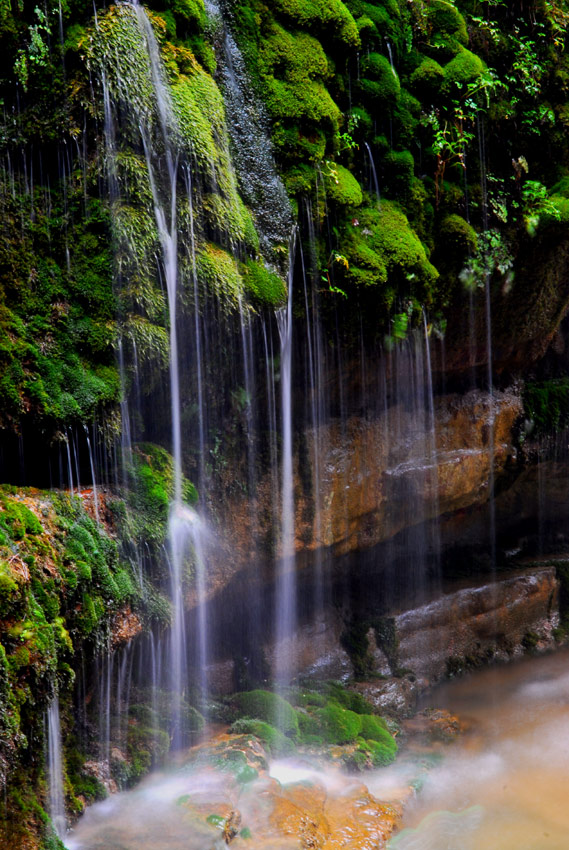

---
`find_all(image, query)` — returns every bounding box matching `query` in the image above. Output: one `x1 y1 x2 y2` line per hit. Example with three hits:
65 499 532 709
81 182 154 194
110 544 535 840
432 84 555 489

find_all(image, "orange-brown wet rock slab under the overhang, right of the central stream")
299 391 522 554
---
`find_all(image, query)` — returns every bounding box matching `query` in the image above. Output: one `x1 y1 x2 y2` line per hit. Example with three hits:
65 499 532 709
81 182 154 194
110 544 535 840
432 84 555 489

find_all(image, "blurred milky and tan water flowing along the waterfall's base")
66 652 569 850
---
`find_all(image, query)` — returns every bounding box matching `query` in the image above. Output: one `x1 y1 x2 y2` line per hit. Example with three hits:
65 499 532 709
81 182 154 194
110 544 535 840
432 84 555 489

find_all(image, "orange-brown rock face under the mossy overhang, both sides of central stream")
220 390 522 576
